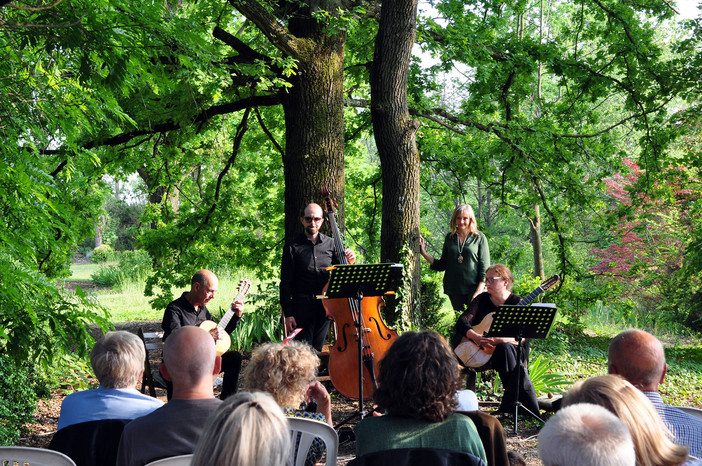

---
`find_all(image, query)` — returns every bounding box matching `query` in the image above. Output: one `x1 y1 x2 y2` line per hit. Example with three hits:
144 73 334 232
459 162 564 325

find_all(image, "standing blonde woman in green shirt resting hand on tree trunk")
419 204 490 312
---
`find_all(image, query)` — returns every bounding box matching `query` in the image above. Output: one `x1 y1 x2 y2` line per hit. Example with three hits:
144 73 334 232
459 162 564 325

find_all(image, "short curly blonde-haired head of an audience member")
243 341 319 409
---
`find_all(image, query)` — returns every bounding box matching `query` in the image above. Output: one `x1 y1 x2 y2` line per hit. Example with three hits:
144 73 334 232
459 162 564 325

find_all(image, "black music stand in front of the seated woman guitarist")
486 304 558 434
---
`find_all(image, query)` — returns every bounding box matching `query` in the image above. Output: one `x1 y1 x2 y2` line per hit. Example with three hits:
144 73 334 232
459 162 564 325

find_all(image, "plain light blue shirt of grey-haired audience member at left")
58 387 163 429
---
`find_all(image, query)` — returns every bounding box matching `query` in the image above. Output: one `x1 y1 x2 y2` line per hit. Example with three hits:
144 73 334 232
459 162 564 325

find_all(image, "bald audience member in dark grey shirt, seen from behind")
117 326 222 466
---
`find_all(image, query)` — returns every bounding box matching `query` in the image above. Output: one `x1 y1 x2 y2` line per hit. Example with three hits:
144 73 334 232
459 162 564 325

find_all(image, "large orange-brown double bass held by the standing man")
322 186 397 399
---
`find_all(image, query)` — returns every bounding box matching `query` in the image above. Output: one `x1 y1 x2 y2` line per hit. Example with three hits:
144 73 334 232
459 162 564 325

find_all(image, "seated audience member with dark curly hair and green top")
356 330 486 461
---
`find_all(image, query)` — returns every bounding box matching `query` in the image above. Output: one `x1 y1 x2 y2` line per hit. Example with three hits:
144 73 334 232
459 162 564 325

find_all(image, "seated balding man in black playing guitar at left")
161 269 244 399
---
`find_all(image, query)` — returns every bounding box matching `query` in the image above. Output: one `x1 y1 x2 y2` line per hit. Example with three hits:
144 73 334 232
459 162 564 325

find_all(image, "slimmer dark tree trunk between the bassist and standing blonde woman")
370 0 421 324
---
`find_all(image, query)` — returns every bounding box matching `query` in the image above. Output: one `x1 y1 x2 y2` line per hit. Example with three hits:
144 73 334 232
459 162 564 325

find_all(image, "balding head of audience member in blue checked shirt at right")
608 329 667 391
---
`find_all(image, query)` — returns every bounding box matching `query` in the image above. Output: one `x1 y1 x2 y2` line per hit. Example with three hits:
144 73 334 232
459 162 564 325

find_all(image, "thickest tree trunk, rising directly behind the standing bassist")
229 0 346 241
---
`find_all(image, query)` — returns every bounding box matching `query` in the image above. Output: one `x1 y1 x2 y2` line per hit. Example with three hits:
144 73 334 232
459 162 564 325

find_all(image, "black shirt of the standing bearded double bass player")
280 233 341 317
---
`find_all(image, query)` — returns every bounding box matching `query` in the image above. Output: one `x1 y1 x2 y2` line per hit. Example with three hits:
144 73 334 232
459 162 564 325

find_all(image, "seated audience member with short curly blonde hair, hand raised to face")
243 340 334 464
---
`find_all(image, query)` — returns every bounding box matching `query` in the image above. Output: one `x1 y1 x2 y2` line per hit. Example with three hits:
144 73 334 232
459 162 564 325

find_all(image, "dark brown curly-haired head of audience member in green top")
373 330 460 422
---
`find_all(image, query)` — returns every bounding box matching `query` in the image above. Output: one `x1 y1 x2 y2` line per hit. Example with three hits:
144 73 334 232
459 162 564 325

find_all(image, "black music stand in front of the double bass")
322 263 402 428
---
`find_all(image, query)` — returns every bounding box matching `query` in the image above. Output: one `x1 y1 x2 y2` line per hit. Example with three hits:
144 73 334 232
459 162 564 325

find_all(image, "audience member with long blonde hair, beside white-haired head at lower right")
563 375 688 466
